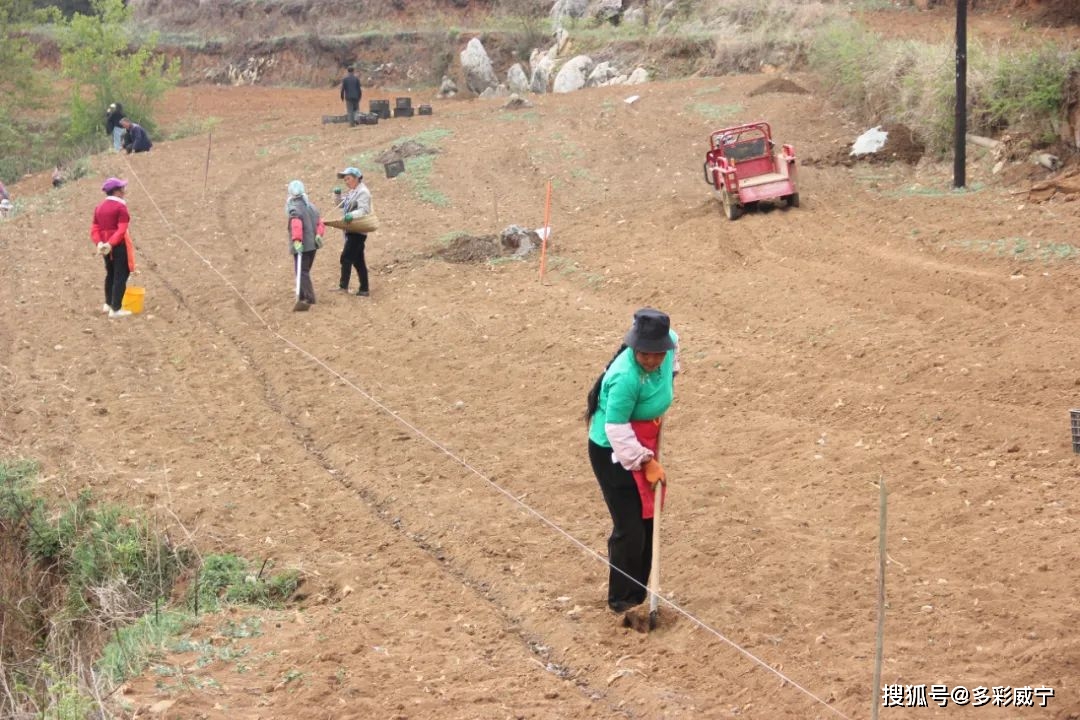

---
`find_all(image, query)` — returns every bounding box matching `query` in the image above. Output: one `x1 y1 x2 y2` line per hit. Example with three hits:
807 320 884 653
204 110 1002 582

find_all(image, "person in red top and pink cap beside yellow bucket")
90 177 135 317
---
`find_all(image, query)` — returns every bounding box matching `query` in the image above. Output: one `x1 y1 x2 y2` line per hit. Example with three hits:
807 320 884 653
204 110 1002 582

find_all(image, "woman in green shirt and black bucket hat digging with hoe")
585 308 679 612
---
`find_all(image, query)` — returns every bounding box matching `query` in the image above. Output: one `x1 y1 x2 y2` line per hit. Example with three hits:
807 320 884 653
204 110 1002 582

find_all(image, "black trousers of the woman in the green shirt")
589 440 652 607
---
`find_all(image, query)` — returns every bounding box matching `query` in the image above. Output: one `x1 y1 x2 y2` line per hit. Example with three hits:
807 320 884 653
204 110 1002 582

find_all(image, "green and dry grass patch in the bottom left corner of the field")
0 460 300 720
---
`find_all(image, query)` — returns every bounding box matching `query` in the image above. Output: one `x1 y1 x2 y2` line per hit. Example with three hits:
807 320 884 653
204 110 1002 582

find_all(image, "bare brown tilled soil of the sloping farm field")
0 16 1080 720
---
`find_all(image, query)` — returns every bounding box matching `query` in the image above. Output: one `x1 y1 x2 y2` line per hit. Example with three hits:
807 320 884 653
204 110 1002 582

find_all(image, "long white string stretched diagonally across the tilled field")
124 158 852 720
